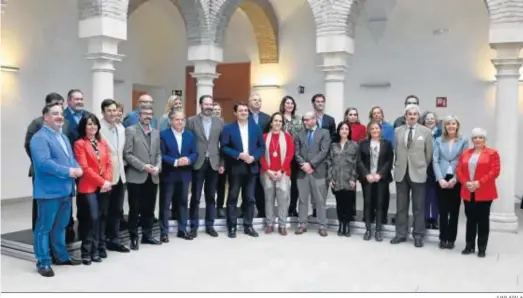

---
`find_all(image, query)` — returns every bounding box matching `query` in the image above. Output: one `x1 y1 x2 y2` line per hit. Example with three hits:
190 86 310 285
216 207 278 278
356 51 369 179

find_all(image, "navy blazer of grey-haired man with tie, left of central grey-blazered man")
160 127 198 182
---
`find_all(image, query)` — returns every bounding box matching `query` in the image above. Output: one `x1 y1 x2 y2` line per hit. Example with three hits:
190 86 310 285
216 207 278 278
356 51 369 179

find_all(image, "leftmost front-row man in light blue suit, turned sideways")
29 103 83 277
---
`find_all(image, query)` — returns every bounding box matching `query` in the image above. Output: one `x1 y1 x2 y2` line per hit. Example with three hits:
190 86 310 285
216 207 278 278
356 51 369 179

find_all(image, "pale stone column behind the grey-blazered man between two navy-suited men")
188 45 223 113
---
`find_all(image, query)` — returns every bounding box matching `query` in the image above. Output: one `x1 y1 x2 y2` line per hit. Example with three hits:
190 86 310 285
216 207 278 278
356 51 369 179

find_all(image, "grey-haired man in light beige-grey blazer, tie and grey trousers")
390 105 433 247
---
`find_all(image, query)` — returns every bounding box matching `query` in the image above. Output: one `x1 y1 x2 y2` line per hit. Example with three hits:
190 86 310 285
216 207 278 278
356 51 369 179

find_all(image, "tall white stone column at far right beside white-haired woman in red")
490 44 523 232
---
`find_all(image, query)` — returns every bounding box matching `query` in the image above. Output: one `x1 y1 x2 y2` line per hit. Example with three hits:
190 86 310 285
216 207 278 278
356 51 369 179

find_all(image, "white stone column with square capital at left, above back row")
79 16 127 116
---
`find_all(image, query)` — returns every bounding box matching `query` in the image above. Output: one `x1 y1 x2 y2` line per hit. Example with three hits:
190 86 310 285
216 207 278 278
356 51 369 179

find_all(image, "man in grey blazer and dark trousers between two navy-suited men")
186 95 224 238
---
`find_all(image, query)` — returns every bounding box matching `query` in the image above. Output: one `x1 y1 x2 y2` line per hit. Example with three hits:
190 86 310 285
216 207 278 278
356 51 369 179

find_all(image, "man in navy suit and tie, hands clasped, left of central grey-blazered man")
160 111 198 243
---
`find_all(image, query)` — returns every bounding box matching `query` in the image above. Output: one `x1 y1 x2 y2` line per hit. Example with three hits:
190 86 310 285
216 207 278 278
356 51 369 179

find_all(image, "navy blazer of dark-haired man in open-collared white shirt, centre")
220 119 265 174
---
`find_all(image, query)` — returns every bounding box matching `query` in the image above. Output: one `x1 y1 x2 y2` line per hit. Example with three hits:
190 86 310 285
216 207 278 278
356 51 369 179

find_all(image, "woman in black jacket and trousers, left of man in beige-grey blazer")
358 121 394 241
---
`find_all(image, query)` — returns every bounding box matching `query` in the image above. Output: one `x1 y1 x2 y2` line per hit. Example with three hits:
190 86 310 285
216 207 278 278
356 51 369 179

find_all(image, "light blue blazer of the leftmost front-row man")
29 125 80 199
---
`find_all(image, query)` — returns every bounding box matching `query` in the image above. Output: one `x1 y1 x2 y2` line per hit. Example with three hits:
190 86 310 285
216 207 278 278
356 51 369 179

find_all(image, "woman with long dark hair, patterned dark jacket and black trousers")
327 121 358 237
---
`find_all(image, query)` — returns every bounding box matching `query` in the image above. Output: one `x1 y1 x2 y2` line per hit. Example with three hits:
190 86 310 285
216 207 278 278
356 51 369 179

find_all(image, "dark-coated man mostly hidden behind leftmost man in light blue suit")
24 92 68 233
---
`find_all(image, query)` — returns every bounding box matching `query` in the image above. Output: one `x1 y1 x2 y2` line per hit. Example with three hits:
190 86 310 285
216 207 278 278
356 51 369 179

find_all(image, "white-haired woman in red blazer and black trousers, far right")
456 128 500 258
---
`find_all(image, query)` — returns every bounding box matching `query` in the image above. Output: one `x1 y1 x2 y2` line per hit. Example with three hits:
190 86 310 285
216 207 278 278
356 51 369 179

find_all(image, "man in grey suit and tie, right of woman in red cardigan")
294 111 331 237
